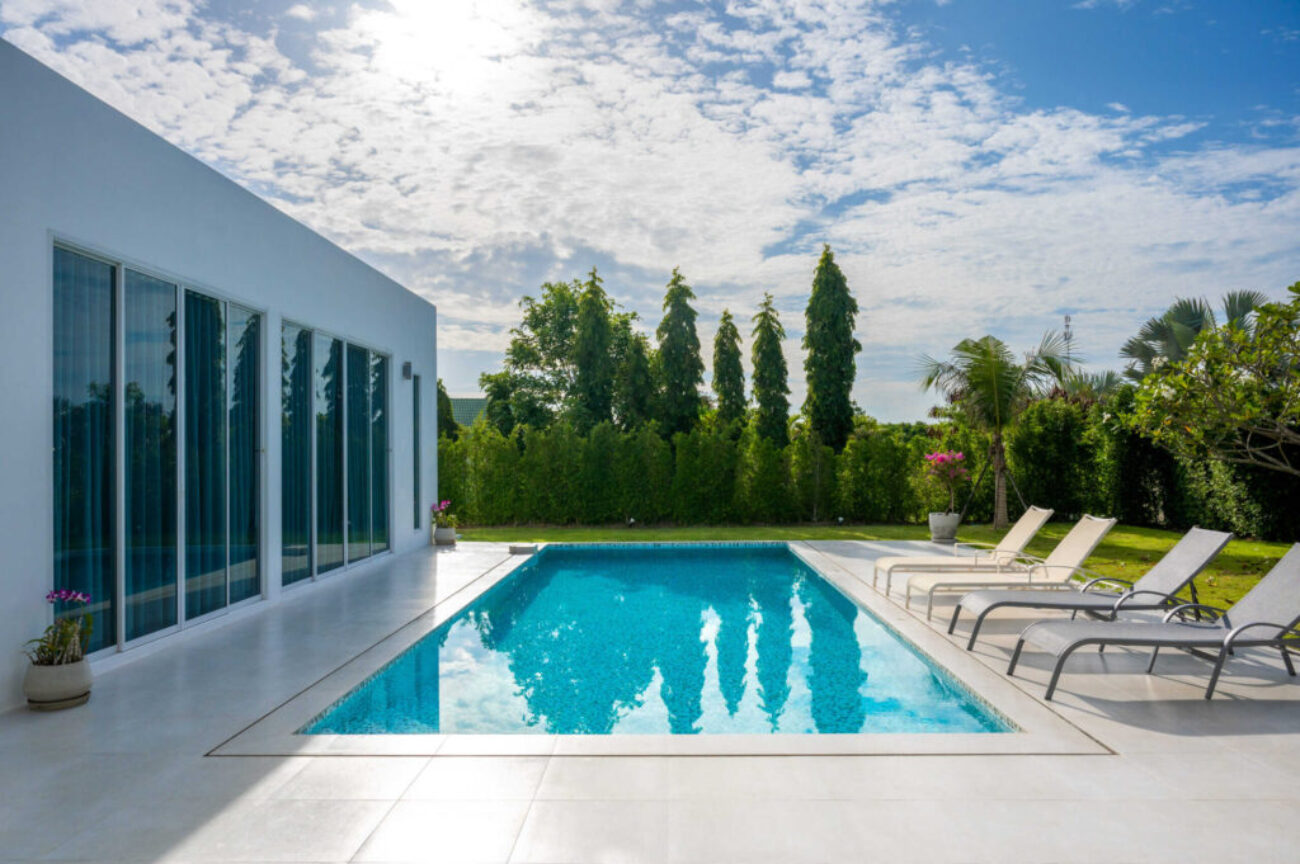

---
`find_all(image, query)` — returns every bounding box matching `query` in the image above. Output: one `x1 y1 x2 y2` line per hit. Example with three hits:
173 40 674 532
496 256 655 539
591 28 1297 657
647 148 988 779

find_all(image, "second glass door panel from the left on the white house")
122 270 177 639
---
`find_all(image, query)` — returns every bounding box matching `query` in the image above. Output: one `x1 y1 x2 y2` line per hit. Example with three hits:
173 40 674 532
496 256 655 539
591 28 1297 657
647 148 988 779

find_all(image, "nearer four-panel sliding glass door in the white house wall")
53 247 261 651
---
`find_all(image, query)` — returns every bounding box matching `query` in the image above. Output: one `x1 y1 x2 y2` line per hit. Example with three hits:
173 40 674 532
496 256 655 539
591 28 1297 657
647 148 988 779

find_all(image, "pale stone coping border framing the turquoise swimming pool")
208 540 1114 756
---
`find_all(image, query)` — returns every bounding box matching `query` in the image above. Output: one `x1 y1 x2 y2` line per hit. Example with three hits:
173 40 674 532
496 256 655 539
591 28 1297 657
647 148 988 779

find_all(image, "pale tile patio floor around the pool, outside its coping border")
0 543 1300 864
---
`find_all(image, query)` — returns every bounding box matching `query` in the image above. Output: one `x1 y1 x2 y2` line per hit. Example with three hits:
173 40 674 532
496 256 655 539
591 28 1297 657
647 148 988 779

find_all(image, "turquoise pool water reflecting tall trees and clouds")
303 544 1009 735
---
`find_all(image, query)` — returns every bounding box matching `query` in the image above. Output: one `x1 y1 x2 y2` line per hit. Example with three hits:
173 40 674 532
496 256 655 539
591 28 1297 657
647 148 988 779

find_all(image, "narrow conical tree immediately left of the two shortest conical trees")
658 268 705 437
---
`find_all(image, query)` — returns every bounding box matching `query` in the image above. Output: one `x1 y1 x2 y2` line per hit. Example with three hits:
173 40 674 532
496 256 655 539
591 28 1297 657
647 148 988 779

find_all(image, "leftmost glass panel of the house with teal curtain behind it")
53 248 117 651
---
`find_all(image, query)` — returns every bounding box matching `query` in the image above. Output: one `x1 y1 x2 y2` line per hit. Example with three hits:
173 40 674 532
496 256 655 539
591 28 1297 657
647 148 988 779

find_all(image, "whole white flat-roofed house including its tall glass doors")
0 42 437 708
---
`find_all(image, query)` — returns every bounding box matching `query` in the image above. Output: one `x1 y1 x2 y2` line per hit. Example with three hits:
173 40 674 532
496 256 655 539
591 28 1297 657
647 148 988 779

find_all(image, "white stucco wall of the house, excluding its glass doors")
0 40 437 709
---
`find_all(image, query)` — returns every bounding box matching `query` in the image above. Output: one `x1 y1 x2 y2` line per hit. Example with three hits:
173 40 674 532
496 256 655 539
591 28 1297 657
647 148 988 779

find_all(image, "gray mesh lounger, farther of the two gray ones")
948 527 1232 651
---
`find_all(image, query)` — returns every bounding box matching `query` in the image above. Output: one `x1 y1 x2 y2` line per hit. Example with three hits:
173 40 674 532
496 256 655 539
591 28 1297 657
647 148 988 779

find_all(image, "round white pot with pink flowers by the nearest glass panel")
22 589 95 711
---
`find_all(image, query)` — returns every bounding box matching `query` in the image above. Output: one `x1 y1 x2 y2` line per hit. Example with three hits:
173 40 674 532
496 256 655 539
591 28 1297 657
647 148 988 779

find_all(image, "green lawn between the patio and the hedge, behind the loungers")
462 522 1288 607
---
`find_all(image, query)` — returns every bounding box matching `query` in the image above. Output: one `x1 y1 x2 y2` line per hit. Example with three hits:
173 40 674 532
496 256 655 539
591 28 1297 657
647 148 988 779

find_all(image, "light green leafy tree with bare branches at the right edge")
1134 282 1300 477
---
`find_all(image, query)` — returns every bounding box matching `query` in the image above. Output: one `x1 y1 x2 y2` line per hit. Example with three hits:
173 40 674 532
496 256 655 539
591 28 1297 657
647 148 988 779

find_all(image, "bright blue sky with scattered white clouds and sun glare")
0 0 1300 421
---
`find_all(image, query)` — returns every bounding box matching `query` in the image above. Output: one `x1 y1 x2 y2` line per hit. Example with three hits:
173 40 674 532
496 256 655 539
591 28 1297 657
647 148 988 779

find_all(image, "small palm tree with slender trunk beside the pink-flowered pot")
919 333 1070 530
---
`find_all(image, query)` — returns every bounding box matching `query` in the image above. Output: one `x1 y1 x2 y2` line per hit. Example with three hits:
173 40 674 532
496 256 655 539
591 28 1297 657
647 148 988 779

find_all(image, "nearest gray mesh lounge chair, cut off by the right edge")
1006 543 1300 699
